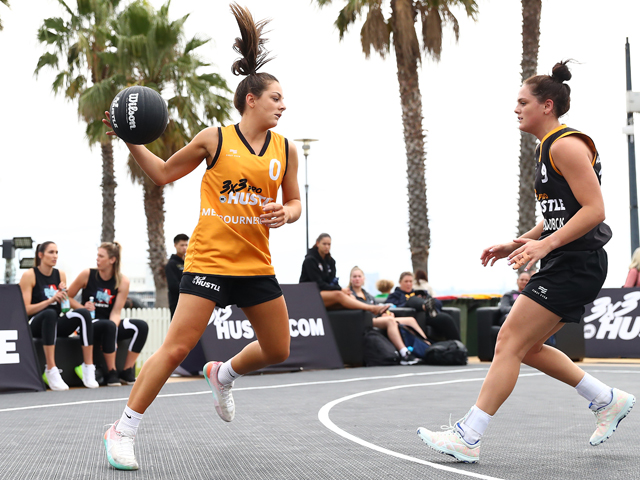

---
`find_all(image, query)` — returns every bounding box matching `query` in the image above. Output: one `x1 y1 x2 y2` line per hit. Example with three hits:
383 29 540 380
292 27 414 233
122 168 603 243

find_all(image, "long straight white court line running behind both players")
0 367 489 413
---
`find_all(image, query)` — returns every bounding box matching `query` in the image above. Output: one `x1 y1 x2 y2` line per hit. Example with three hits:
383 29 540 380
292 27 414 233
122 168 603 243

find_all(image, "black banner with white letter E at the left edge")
0 285 45 393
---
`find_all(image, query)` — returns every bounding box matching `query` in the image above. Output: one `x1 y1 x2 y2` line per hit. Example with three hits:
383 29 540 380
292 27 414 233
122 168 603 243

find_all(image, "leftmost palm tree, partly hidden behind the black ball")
35 0 121 242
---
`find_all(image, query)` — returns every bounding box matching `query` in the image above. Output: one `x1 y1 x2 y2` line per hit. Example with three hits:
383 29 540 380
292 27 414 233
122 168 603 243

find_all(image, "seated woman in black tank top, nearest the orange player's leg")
69 242 149 386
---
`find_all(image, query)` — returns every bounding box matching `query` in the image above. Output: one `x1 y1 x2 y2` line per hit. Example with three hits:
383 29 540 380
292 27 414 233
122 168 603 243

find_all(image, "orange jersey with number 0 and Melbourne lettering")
184 125 289 277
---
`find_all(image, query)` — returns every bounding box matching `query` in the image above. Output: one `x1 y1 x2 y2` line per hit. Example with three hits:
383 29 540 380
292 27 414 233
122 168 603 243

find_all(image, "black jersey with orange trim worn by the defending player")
535 125 611 251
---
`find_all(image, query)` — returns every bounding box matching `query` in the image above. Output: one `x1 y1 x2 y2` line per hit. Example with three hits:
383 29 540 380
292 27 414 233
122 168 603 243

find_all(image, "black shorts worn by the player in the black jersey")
522 248 608 323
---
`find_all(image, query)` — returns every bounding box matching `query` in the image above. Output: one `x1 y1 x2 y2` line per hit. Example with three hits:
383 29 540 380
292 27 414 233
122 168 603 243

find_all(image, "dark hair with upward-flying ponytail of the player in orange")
231 3 278 115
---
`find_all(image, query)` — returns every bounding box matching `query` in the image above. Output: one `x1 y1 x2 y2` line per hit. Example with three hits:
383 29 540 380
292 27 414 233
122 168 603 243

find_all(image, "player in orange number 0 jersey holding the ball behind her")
103 4 300 470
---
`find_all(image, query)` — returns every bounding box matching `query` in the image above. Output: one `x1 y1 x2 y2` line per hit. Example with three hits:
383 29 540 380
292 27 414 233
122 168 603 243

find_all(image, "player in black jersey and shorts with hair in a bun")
418 62 635 463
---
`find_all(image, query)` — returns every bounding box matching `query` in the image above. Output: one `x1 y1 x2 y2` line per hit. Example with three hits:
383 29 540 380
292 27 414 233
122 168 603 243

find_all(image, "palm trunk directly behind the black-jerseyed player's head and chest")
518 0 542 236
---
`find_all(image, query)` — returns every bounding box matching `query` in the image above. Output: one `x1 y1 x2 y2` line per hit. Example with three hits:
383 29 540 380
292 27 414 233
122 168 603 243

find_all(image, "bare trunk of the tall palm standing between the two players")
391 1 431 272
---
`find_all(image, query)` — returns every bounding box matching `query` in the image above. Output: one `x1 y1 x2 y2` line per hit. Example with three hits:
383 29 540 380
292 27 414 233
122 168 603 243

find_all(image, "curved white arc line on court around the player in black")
318 372 544 480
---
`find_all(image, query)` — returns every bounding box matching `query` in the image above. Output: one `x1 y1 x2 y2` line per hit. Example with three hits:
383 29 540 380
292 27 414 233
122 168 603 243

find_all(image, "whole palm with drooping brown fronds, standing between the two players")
317 0 478 271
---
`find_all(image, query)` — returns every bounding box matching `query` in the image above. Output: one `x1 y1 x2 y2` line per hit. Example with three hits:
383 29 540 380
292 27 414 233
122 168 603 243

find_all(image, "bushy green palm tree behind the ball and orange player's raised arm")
96 1 231 307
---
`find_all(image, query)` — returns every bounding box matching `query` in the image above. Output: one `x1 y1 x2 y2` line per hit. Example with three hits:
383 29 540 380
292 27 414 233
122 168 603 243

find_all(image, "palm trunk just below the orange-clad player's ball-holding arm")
144 178 169 307
